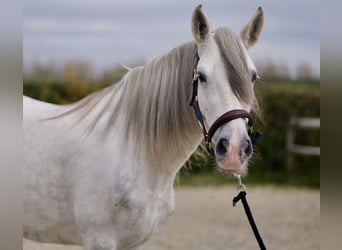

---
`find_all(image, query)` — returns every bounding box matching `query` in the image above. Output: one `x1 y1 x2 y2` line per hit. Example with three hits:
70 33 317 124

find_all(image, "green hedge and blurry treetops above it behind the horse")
23 62 320 188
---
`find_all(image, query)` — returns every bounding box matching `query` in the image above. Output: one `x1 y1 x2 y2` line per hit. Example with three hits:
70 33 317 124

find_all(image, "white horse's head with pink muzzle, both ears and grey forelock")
192 5 264 174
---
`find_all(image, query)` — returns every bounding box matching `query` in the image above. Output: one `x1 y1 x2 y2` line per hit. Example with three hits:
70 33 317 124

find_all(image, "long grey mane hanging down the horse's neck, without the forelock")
115 42 199 161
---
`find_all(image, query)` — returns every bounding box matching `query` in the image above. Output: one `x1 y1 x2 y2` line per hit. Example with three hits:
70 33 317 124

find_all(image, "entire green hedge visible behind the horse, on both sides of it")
24 81 320 187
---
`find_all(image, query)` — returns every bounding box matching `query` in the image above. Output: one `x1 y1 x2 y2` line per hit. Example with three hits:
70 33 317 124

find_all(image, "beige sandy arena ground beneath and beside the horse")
23 186 320 250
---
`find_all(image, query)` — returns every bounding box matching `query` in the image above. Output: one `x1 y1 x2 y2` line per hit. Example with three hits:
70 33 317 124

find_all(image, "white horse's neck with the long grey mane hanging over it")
80 43 201 178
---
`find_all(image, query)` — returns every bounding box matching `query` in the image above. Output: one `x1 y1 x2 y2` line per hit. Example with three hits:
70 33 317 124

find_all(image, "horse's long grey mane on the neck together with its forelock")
52 28 257 164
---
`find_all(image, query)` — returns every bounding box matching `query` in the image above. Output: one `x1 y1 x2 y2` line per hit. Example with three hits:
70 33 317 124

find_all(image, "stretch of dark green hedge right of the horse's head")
251 82 320 187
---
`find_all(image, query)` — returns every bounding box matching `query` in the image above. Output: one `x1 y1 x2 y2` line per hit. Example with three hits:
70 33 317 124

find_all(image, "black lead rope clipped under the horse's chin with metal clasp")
233 176 266 250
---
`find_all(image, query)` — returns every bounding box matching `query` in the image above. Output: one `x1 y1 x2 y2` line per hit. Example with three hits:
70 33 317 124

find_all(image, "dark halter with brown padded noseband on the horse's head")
190 69 261 156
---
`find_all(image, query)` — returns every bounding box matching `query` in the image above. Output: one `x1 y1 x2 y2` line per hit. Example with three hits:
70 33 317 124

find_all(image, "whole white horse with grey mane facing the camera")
23 5 264 250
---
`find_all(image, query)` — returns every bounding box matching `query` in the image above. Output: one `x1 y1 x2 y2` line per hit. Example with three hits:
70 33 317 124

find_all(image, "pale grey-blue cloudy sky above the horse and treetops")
23 0 320 76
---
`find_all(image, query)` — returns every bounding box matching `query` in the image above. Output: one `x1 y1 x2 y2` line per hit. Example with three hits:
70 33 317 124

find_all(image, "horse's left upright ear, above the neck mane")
191 4 210 44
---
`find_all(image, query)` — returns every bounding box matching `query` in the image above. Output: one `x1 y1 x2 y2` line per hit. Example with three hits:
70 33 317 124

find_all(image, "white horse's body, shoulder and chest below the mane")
24 94 187 249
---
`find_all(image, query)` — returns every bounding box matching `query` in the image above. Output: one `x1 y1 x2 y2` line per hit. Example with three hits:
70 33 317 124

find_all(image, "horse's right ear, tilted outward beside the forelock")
240 7 264 49
